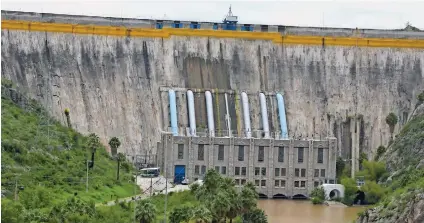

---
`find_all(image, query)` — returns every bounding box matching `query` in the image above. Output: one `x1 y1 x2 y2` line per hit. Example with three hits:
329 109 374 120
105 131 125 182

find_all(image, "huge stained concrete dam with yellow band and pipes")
1 11 424 168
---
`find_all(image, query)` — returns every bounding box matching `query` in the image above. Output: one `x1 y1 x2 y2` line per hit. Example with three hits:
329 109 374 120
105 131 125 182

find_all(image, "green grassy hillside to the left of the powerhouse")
1 80 139 222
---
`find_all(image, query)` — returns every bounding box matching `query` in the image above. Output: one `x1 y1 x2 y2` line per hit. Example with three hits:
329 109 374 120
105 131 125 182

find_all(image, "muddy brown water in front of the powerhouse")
258 199 365 223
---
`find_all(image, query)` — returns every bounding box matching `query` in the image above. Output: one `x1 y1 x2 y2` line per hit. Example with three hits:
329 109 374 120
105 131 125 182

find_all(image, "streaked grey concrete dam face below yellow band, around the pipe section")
2 30 424 156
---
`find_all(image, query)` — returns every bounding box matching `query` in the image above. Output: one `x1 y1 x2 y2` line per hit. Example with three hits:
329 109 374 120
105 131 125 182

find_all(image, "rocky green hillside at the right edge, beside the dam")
357 105 424 223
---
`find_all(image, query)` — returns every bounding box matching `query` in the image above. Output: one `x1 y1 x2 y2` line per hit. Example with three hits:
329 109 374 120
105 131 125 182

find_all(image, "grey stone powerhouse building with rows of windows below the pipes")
158 133 336 198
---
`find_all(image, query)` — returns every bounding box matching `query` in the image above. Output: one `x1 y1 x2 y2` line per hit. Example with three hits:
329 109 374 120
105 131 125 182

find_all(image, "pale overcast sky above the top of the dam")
1 0 424 29
